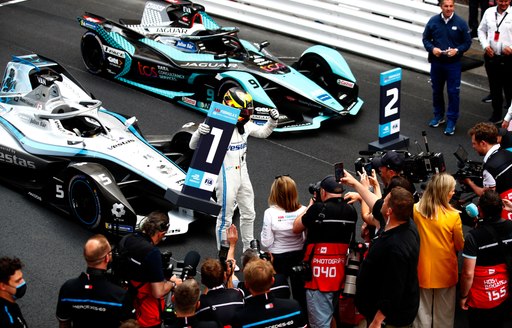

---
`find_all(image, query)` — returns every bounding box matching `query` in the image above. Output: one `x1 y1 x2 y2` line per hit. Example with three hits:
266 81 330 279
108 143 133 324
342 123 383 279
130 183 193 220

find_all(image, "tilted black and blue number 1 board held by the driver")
182 102 240 200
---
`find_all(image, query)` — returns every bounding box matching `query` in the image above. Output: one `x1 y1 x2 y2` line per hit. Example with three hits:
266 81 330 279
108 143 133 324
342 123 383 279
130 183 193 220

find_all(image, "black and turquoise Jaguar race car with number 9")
78 0 363 132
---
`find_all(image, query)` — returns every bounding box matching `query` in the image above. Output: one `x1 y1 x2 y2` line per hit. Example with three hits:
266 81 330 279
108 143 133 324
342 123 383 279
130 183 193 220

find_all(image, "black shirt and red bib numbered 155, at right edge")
462 219 512 327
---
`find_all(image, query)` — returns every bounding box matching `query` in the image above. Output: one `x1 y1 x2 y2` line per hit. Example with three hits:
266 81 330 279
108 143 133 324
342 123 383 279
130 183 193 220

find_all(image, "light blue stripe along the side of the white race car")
0 117 178 190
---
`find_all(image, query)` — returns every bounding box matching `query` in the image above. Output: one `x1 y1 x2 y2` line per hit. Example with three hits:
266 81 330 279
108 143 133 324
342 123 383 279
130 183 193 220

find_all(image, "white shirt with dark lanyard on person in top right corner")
478 6 512 55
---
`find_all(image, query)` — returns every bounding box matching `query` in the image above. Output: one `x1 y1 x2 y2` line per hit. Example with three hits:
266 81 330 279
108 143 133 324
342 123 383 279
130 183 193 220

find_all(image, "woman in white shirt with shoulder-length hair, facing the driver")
261 175 306 310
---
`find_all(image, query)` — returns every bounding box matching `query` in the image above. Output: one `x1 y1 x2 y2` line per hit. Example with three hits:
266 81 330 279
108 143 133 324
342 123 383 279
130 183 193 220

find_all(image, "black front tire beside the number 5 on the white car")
68 174 101 230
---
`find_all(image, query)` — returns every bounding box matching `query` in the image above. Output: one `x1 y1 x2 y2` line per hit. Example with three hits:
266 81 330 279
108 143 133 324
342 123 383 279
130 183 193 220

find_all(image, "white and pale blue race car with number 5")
0 54 218 235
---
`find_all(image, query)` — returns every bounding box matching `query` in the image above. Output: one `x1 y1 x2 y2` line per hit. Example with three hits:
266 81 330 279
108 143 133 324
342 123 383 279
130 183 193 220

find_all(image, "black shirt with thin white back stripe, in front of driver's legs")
196 286 244 326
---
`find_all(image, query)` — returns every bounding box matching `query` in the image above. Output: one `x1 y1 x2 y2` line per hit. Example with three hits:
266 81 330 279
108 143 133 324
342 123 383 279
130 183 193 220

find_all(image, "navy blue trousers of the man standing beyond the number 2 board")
430 61 461 124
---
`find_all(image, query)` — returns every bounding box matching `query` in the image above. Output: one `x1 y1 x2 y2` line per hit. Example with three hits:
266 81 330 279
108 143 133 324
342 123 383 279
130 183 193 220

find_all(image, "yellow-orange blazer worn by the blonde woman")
413 204 464 288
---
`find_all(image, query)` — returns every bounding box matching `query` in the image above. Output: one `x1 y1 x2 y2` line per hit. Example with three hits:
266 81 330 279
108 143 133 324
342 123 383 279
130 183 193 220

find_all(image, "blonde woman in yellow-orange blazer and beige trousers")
413 173 464 327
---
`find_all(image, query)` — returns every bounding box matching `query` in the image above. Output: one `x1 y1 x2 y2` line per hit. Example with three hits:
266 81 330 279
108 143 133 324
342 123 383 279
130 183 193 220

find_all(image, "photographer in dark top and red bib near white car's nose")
118 212 181 327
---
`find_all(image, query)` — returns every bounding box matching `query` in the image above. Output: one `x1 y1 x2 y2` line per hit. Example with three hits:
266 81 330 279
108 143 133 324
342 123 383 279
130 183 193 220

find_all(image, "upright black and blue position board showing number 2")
379 68 402 144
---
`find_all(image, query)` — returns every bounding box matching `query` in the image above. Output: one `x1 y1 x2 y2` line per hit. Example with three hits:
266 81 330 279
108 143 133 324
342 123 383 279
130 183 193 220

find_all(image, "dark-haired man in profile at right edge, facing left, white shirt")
464 123 512 215
